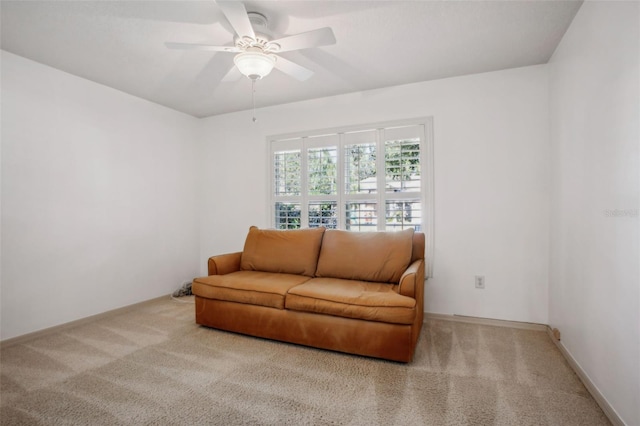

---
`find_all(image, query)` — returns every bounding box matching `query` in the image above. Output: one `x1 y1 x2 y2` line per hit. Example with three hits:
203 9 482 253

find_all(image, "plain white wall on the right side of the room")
549 1 640 425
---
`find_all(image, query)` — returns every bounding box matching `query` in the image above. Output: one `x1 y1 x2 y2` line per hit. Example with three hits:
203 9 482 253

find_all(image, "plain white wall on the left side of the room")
0 52 199 339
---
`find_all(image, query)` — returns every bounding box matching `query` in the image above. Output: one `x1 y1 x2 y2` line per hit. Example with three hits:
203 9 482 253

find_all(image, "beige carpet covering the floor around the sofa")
0 298 609 426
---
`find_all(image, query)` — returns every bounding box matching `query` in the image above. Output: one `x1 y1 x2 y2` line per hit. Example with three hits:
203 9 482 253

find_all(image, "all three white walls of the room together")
0 5 640 425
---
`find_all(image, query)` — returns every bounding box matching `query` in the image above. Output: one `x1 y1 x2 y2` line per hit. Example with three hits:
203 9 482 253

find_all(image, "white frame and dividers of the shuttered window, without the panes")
267 117 435 277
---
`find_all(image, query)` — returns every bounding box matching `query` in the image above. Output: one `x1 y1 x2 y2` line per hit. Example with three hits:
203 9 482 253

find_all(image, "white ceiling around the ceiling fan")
0 0 581 117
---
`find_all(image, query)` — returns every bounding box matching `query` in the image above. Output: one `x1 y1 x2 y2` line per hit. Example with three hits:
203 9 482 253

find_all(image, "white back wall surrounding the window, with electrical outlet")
200 66 549 323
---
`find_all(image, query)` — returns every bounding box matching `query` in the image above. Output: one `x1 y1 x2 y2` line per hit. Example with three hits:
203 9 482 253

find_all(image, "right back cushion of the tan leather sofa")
316 229 413 283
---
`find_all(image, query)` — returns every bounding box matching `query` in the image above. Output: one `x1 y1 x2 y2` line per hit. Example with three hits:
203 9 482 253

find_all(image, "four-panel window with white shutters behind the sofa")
269 118 433 240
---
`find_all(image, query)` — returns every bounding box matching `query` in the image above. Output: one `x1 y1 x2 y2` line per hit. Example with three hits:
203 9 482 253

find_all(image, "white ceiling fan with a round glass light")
165 1 336 82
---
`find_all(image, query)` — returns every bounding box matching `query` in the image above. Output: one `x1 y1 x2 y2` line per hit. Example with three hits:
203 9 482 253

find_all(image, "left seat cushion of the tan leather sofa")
191 271 309 309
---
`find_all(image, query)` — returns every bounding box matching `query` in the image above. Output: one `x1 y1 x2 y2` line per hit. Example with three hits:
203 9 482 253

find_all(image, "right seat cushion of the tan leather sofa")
285 278 416 324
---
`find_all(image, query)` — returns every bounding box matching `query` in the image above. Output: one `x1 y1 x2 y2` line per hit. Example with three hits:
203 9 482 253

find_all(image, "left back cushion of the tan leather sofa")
240 226 325 277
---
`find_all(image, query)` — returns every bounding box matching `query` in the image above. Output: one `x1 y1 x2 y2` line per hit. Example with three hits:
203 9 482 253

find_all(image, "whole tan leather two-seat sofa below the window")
192 227 425 362
